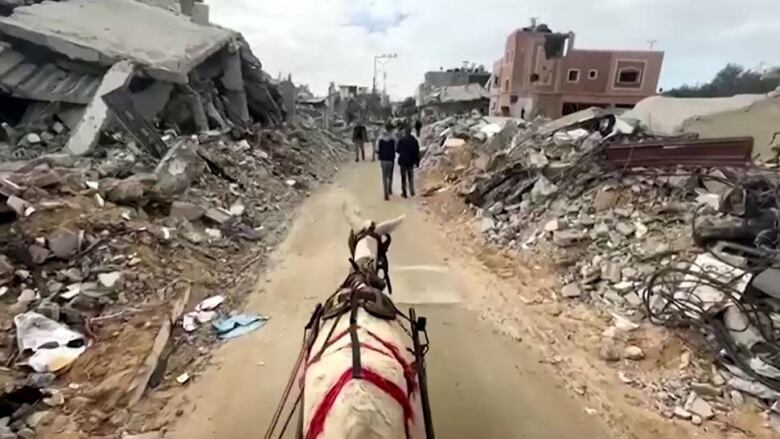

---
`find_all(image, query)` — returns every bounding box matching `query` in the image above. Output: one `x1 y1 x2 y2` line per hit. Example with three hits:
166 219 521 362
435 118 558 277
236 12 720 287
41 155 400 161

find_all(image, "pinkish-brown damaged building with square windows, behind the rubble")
489 24 664 118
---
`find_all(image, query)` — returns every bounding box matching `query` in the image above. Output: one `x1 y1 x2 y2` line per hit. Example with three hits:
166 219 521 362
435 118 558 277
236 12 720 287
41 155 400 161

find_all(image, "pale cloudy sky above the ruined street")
208 0 780 98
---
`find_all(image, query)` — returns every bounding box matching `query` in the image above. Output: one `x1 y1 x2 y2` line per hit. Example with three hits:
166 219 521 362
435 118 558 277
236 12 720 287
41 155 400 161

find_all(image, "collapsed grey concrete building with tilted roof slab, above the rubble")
0 0 285 158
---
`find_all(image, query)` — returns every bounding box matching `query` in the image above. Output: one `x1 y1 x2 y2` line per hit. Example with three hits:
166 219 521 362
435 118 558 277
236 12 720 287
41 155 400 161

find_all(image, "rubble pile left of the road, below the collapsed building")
0 112 347 437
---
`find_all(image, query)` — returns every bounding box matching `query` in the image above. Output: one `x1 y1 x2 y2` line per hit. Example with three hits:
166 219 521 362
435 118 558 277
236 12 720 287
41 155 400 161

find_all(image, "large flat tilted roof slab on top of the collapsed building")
0 0 236 83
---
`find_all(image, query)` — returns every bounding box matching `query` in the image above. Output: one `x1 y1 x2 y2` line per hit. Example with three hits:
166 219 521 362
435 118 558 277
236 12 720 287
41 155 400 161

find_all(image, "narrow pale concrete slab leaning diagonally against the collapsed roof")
66 61 135 156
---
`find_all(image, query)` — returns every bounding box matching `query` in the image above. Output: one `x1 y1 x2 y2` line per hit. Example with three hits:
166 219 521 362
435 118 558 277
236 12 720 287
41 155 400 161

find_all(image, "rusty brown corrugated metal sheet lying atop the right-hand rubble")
604 137 753 168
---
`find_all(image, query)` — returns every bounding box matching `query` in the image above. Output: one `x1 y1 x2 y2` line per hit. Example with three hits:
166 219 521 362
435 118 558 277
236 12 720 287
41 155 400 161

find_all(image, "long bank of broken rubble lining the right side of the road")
423 105 780 438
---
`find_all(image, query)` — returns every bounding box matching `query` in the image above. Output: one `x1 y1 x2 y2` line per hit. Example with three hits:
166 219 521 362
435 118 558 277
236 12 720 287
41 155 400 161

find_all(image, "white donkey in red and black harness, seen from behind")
301 209 425 439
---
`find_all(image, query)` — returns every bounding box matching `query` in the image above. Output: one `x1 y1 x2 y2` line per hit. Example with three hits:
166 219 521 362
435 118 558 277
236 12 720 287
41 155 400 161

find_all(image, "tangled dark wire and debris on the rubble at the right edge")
642 170 780 391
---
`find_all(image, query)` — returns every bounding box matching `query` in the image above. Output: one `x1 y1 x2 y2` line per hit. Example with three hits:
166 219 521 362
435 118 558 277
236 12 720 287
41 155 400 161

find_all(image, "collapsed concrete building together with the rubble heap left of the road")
0 0 349 439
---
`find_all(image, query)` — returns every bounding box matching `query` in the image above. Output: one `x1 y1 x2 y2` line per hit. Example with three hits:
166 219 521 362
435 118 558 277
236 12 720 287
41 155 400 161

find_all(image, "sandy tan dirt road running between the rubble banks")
170 163 609 439
